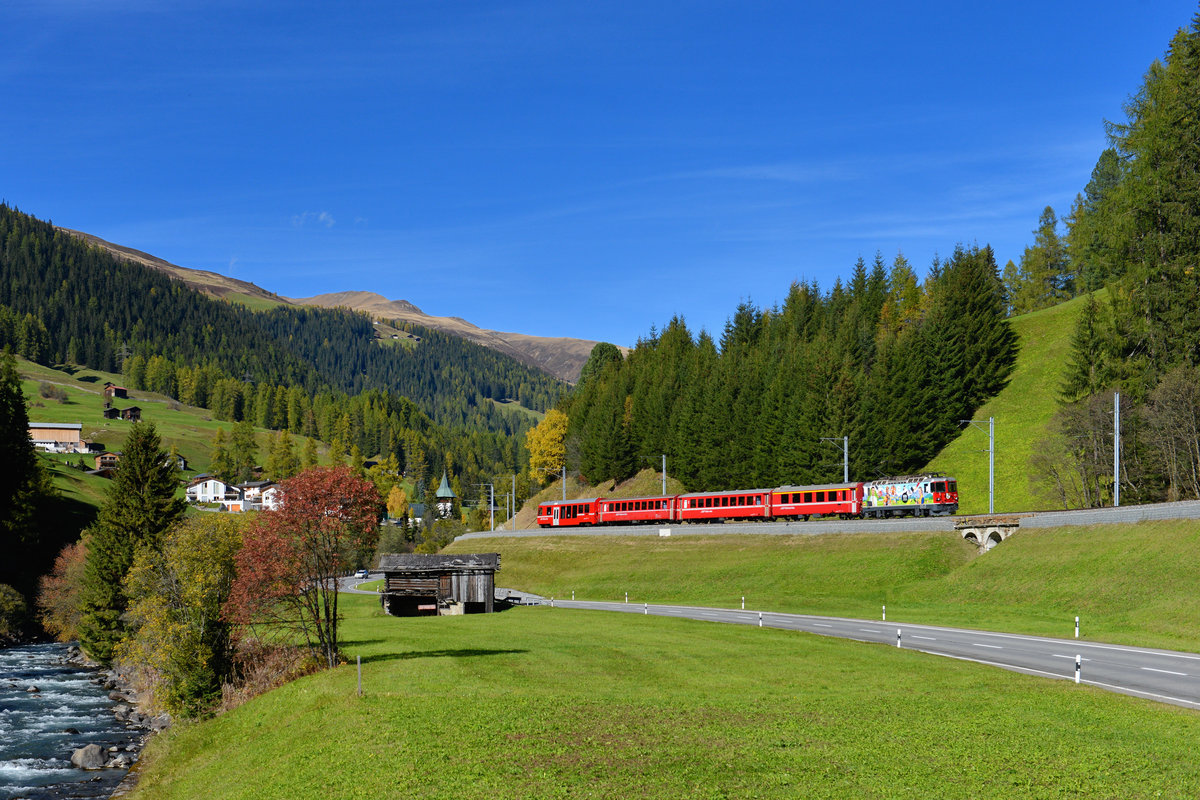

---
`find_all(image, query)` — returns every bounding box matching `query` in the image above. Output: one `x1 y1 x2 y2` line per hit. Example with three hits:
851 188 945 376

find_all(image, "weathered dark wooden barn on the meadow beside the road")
379 553 500 616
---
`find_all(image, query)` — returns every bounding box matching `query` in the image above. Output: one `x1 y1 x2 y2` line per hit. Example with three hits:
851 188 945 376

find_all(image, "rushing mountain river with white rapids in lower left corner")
0 643 144 800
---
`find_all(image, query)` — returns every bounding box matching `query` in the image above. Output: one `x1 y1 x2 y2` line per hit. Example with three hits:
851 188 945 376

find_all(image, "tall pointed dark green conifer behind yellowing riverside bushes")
79 422 186 663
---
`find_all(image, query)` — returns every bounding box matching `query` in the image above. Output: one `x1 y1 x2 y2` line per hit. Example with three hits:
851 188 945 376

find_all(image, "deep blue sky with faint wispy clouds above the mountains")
0 0 1198 344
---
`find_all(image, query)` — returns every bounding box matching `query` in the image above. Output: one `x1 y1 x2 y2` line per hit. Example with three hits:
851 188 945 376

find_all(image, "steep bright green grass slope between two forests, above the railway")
916 297 1087 513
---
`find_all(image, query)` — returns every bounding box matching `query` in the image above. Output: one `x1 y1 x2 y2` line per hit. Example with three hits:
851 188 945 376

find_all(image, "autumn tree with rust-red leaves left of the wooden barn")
226 465 382 667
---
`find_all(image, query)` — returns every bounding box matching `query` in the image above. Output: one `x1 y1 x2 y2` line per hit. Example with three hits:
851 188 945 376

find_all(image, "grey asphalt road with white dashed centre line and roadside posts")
544 600 1200 709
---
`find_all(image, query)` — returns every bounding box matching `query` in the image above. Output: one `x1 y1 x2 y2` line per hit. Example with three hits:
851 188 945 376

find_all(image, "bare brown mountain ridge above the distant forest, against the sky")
58 228 625 383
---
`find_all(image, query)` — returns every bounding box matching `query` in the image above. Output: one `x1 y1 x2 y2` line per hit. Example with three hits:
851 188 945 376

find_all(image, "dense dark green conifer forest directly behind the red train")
564 247 1016 489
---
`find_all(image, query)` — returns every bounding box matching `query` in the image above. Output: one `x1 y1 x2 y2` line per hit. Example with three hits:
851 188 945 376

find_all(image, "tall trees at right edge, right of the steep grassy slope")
1026 14 1200 506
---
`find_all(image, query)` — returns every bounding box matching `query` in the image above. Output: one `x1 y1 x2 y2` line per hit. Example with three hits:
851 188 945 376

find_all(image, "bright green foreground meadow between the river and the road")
133 596 1200 800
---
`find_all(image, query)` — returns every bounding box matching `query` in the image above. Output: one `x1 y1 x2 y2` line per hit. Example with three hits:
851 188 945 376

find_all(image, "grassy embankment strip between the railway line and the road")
446 521 1200 651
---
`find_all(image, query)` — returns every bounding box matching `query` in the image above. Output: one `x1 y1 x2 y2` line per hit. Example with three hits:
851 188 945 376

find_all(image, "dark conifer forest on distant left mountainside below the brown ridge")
0 205 562 433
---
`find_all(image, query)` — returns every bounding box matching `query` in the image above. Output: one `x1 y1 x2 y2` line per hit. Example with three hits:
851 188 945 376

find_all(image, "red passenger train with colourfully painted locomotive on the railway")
538 473 959 528
